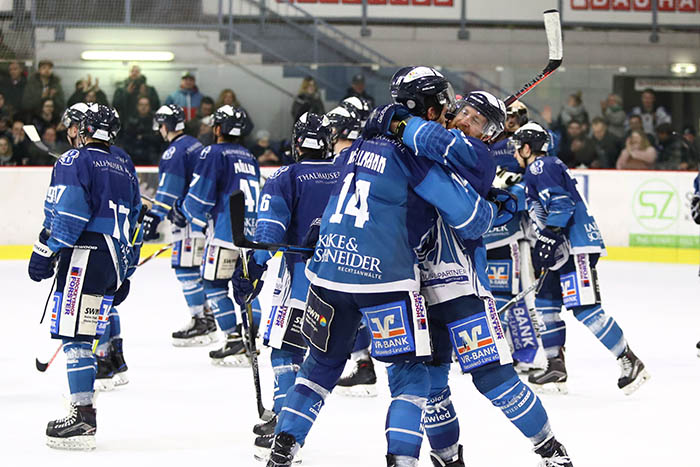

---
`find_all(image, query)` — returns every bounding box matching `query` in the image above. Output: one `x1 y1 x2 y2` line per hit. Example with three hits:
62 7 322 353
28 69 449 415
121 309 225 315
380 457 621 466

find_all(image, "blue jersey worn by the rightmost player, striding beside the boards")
524 156 605 255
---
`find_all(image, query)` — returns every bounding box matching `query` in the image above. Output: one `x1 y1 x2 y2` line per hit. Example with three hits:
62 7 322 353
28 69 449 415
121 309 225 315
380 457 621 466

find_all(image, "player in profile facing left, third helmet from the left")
143 104 217 347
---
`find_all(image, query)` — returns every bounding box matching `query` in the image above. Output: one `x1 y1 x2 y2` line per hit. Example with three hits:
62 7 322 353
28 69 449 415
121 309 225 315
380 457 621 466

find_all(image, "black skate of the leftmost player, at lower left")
46 405 97 451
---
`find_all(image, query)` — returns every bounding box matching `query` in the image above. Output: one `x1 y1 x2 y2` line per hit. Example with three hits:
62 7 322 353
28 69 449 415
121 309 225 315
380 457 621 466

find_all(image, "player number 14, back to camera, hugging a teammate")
267 67 494 467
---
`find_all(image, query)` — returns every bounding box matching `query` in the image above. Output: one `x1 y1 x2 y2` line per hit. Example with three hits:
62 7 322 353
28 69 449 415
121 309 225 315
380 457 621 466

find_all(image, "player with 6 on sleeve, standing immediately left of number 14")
232 113 340 460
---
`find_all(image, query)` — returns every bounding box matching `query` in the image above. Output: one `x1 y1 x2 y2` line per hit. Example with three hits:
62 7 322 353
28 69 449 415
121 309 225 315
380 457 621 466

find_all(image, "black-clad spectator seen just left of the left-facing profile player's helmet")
122 96 164 165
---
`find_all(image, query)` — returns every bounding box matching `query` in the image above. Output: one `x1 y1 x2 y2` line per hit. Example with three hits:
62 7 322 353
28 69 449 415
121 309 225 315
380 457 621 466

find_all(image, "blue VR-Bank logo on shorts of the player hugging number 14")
447 312 500 372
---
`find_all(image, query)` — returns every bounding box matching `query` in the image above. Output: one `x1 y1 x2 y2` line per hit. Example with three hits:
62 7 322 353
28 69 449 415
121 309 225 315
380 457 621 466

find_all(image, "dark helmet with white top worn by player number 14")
389 66 454 117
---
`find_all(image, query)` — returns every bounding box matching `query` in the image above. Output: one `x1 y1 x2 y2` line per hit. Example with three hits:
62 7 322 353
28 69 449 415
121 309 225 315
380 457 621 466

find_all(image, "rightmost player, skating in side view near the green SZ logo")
513 122 649 395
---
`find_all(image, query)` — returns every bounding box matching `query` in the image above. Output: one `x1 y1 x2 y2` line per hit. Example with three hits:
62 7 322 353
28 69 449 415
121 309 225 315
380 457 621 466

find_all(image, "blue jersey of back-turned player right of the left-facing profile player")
182 143 260 249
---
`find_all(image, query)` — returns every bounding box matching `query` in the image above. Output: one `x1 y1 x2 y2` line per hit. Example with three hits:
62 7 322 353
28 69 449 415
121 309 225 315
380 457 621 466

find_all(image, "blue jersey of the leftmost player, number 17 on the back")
43 143 141 283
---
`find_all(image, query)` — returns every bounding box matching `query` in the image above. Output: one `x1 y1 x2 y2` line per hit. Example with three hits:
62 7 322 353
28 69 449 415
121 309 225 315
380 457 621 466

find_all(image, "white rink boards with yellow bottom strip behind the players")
0 167 700 264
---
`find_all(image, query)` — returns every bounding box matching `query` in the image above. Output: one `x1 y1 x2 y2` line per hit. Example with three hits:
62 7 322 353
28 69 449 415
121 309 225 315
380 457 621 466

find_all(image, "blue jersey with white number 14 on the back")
306 136 494 293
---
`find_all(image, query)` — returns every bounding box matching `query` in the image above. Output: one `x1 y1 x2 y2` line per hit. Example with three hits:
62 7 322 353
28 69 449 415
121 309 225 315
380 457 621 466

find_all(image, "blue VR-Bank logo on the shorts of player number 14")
360 302 415 357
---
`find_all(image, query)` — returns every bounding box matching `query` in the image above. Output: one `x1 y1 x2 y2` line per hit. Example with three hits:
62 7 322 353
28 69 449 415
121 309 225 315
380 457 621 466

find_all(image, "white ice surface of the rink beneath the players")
0 260 700 467
